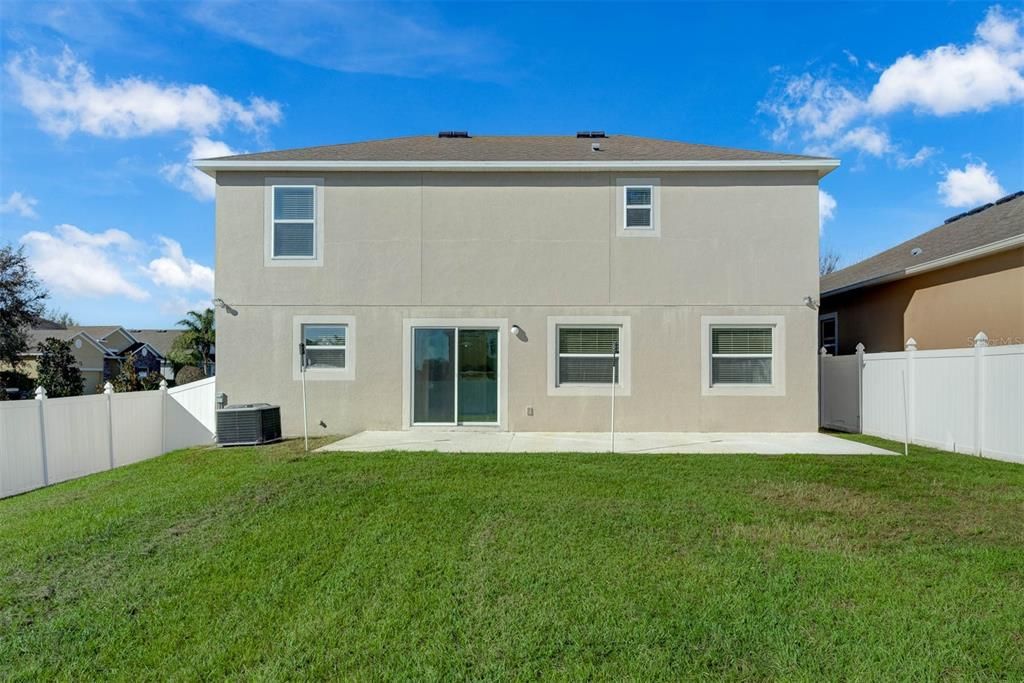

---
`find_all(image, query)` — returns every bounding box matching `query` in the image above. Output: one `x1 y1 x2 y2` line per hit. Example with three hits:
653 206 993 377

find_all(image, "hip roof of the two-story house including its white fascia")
196 135 839 172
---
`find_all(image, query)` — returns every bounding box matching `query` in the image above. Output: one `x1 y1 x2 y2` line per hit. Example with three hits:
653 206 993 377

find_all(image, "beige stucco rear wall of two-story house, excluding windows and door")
216 167 818 434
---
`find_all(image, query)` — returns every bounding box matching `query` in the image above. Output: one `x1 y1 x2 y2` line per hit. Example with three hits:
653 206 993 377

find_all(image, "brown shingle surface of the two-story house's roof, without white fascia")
204 135 823 162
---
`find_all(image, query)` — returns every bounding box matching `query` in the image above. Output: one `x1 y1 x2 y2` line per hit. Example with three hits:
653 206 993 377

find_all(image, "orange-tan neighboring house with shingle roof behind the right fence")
818 193 1024 354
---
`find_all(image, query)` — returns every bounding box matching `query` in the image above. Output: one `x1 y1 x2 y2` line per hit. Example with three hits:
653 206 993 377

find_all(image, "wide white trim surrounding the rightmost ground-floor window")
700 315 786 396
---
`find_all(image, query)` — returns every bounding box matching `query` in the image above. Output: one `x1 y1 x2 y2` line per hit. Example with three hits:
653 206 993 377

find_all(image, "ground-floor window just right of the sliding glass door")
557 326 622 386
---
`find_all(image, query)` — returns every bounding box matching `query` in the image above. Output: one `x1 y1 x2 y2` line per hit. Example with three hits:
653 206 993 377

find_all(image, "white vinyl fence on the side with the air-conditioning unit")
0 377 216 498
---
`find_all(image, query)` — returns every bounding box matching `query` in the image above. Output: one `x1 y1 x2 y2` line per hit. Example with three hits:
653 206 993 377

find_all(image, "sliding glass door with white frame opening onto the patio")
412 328 499 425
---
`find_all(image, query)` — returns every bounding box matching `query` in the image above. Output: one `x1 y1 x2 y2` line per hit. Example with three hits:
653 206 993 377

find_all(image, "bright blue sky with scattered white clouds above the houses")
0 0 1024 327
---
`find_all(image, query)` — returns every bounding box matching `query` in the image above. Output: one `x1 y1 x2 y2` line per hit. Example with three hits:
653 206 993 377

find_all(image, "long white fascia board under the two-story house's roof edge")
193 159 840 177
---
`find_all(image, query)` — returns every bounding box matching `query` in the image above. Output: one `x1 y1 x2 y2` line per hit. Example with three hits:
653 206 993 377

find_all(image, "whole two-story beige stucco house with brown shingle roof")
197 133 839 434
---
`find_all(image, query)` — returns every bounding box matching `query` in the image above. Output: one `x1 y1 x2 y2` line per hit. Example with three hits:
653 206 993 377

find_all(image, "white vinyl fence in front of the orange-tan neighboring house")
818 332 1024 463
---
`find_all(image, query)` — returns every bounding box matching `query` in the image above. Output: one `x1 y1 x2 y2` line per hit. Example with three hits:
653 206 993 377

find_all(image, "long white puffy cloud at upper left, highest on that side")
5 47 282 137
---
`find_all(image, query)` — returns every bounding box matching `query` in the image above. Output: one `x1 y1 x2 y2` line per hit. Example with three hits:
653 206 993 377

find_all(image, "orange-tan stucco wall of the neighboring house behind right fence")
820 248 1024 354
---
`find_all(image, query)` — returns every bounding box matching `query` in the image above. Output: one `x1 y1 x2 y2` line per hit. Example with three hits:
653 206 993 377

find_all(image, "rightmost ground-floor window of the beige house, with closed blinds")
711 325 773 387
